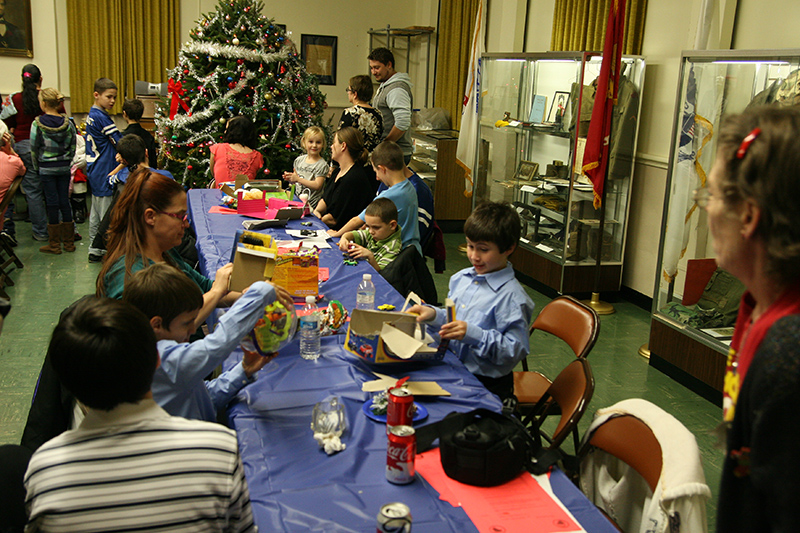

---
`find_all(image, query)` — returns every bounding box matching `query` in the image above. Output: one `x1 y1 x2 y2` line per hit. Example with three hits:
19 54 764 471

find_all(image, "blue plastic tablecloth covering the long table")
189 190 614 532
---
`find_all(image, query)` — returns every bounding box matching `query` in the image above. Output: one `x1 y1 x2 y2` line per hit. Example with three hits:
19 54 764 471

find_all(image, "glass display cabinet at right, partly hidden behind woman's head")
649 50 800 403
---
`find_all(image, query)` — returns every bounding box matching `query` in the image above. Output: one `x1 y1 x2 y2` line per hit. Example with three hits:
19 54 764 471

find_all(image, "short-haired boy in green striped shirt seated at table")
339 198 402 272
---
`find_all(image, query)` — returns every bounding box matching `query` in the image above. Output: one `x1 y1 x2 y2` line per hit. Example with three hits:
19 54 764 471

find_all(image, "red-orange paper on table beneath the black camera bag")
415 448 581 533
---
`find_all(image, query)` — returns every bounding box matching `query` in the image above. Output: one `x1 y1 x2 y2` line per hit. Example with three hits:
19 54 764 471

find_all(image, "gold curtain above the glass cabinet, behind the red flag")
550 0 647 55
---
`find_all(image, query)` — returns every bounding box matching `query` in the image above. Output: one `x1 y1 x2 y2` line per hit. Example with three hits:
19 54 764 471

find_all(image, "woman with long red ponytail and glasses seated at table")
97 168 241 327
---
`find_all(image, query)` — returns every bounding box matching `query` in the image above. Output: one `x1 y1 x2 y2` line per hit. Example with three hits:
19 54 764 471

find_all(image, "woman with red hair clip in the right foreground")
712 107 800 531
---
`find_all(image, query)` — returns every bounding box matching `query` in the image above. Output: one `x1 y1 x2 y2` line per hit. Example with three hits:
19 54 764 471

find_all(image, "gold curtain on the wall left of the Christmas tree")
67 0 180 113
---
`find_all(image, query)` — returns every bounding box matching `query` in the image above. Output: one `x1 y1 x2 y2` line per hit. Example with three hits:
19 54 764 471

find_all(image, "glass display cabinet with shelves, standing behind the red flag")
474 52 645 293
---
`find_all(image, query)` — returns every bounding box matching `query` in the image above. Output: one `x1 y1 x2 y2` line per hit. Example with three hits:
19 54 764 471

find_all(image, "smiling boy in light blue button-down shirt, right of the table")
409 202 533 401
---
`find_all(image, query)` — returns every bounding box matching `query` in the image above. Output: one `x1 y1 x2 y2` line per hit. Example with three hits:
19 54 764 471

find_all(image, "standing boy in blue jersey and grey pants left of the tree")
86 78 121 263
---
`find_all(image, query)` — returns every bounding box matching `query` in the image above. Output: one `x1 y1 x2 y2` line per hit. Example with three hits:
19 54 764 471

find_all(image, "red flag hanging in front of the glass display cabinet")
583 0 625 209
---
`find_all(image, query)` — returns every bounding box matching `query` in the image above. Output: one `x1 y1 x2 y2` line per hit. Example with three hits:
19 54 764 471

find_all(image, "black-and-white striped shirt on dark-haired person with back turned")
25 400 256 533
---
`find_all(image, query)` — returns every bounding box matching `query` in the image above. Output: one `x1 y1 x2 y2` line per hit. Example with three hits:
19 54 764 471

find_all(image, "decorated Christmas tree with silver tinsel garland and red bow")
155 0 326 187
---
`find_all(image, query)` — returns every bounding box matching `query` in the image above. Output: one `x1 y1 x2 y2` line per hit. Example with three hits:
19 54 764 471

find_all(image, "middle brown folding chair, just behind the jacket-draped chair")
525 358 594 452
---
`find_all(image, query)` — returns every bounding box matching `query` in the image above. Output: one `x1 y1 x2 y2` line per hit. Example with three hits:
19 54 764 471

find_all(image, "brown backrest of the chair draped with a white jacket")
578 415 663 492
